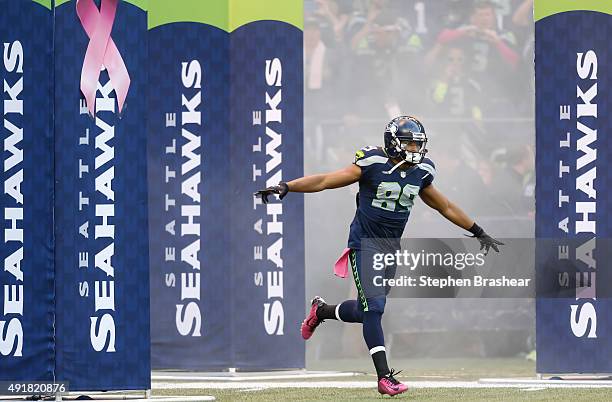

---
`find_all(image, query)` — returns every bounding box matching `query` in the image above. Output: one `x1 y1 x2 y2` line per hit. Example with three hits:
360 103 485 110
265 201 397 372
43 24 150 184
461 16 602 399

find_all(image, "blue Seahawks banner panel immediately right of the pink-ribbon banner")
148 1 232 369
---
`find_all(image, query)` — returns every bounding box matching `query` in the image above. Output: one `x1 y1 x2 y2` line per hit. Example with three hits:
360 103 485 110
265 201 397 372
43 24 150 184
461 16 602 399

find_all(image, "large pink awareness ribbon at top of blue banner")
76 0 130 116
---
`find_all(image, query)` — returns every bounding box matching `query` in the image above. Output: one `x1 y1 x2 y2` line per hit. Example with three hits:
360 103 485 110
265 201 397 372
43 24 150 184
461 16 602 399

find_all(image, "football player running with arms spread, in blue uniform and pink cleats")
255 116 502 395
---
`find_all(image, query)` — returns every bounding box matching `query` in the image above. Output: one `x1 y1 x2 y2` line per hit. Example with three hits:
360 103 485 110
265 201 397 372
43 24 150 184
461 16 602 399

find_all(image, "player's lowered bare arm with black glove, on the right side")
419 184 504 254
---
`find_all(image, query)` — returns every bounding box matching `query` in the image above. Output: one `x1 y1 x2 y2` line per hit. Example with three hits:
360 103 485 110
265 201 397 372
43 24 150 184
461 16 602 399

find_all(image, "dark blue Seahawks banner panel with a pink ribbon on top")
54 0 150 391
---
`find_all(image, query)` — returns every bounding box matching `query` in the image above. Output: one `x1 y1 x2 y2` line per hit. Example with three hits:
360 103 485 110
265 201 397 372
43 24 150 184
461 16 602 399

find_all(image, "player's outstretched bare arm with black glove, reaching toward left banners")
255 164 361 203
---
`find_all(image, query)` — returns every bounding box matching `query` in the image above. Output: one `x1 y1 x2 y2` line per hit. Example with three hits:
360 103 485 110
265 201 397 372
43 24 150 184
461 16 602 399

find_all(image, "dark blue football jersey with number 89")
348 147 436 250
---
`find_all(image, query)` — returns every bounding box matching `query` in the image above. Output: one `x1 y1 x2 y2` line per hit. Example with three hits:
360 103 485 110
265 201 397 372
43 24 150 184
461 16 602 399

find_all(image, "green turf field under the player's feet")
153 358 612 402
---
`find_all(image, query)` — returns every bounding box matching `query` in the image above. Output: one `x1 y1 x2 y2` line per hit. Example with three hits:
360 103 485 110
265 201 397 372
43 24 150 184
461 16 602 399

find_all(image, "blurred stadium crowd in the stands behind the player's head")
304 0 535 219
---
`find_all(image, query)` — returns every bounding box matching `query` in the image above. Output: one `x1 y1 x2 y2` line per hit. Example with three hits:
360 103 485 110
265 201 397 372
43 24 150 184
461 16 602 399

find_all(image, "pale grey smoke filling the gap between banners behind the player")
304 0 535 367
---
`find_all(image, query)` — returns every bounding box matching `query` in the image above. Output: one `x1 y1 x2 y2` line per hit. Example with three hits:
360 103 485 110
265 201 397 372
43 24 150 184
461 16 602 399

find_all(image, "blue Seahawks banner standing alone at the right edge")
535 0 612 373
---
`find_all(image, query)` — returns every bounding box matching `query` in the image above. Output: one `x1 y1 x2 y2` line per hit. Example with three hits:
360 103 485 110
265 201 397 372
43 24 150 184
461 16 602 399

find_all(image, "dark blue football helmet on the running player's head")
384 116 427 165
